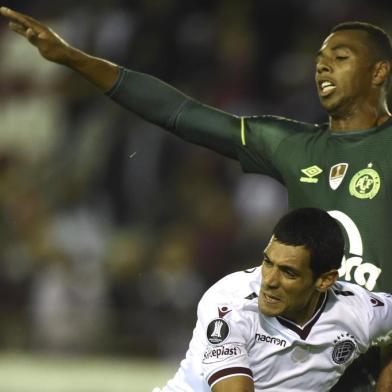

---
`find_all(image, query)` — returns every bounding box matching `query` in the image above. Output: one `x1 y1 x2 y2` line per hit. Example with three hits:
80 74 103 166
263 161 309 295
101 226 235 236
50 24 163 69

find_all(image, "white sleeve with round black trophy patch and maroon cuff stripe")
198 292 253 388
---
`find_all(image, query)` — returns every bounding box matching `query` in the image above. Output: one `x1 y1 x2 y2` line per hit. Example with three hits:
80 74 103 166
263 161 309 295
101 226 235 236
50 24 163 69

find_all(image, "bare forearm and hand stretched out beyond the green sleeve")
0 7 118 91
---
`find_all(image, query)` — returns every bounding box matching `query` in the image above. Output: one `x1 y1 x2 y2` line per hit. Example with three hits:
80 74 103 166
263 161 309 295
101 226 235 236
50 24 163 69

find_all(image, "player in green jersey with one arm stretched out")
0 7 392 392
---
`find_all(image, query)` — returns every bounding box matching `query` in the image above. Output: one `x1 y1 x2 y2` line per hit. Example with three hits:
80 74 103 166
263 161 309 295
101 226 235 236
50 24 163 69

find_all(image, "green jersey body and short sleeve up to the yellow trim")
238 116 392 291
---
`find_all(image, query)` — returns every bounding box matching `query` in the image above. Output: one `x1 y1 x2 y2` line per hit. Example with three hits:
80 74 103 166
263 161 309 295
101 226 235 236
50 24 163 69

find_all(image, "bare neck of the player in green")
329 102 391 132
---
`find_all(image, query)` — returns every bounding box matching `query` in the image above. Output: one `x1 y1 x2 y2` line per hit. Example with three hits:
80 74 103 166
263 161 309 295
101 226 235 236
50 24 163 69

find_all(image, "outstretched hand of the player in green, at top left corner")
0 7 73 64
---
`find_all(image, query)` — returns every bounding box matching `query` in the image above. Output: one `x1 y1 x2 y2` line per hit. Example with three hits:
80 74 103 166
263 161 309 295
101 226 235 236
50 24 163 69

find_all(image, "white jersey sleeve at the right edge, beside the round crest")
368 293 392 344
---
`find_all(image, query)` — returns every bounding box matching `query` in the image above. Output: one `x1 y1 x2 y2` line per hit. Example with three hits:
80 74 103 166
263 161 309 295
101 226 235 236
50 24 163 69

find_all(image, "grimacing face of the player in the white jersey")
259 237 319 323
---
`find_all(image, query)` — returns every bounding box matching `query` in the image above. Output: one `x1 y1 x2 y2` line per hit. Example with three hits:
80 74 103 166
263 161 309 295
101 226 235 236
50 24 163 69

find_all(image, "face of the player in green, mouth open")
316 30 373 117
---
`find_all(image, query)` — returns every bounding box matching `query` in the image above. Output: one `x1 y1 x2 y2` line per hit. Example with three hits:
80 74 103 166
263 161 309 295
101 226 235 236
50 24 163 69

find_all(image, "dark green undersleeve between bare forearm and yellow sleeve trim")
106 68 241 159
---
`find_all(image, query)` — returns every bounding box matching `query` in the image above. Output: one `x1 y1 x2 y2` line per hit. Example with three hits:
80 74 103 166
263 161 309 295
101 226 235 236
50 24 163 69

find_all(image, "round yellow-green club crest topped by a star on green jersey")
349 163 381 199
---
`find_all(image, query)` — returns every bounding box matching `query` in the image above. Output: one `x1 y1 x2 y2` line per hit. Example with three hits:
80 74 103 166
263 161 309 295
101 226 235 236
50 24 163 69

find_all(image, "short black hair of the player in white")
273 208 344 279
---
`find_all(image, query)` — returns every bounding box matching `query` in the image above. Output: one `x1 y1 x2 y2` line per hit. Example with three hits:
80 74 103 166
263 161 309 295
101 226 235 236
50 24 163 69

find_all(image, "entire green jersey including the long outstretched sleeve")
107 68 392 291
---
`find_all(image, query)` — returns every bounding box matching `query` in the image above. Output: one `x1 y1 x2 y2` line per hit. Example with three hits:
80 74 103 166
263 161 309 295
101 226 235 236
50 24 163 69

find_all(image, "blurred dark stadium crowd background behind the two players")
0 0 392 392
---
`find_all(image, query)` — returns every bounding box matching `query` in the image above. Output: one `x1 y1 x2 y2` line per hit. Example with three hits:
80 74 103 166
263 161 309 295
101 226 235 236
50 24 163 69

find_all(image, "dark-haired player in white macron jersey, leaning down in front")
154 208 392 392
